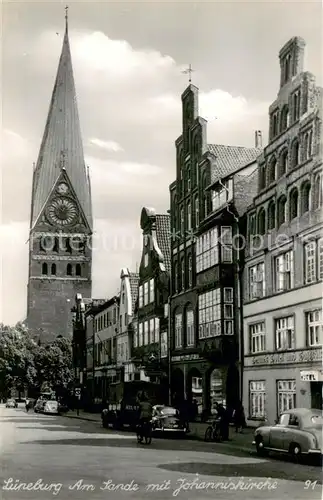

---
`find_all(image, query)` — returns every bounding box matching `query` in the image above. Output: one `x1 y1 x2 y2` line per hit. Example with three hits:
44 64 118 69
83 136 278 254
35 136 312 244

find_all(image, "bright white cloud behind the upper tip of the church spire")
28 30 180 90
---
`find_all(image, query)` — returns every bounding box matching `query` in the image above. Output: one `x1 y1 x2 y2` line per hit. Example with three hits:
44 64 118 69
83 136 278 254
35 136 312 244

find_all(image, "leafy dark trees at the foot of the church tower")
0 323 73 395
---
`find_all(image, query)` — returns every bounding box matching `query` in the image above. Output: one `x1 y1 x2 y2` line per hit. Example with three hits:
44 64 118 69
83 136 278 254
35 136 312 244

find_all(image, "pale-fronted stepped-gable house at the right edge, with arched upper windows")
243 37 323 426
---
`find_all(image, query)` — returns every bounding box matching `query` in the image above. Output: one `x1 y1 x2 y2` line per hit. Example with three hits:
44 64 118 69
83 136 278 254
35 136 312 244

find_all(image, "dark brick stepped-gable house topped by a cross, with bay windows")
170 85 261 411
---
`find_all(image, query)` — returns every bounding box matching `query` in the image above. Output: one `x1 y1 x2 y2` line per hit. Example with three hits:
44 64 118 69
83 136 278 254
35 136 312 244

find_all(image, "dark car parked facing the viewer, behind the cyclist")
152 405 189 436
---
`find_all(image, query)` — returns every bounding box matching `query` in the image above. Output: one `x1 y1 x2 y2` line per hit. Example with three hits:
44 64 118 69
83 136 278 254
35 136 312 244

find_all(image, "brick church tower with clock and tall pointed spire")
27 9 93 338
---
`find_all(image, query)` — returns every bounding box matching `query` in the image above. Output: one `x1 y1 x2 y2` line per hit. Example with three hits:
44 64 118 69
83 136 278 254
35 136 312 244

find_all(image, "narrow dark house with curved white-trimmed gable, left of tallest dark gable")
132 207 171 394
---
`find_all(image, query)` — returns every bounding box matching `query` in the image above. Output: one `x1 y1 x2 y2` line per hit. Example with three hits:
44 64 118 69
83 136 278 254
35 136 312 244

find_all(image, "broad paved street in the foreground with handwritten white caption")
0 407 321 500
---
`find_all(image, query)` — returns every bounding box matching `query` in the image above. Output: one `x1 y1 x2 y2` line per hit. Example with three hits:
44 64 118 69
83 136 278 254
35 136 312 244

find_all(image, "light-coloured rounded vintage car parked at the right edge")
253 408 323 457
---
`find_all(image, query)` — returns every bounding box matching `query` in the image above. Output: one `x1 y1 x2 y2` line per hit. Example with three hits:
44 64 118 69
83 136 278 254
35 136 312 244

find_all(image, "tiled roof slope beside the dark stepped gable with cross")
207 144 263 183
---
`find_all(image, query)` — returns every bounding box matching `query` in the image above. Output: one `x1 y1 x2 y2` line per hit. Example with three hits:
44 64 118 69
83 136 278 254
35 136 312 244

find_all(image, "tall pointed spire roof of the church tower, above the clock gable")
31 17 92 228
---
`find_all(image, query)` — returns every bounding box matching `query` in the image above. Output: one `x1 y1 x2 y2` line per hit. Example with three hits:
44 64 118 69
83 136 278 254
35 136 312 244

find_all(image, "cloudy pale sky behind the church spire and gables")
0 0 322 323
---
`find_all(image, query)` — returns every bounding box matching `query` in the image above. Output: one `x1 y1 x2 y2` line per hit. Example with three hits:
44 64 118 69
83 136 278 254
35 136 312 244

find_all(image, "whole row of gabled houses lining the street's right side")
74 37 323 425
